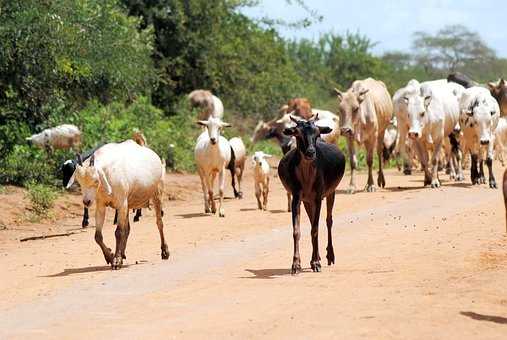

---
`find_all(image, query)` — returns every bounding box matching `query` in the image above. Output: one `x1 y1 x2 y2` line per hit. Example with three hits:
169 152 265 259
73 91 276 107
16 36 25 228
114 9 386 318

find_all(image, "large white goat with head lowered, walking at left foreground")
67 140 169 269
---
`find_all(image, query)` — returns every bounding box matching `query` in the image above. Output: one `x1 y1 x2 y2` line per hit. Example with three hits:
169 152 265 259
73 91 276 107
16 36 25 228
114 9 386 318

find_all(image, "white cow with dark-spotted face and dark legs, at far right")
460 86 500 188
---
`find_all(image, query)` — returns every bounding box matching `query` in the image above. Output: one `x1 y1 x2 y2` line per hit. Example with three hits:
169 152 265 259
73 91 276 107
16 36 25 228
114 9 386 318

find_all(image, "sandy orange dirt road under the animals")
0 166 507 339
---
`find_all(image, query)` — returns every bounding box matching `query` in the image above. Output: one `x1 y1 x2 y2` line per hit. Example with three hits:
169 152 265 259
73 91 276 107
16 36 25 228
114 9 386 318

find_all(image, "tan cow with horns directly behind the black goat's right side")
335 78 393 193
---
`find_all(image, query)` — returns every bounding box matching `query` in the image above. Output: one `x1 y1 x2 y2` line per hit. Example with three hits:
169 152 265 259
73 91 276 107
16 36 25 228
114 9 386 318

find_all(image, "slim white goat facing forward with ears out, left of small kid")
194 117 231 217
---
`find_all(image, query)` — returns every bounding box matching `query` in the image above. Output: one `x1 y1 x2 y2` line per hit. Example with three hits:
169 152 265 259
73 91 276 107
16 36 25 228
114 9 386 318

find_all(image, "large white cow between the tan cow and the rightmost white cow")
395 80 463 188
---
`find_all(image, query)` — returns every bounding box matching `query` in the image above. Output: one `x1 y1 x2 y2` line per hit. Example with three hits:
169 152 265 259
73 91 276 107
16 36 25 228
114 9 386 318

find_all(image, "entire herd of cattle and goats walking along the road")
24 74 507 274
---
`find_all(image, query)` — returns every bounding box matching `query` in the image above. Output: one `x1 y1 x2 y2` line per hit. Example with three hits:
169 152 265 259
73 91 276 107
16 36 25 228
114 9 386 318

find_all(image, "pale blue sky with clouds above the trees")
243 0 507 57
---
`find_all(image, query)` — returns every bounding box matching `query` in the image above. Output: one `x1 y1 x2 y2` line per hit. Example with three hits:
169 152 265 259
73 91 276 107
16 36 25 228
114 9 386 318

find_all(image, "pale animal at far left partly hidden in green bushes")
26 124 81 151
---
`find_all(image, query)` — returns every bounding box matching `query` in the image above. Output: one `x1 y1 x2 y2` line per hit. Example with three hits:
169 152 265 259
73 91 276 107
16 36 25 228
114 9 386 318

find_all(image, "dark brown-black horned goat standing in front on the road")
278 117 345 274
